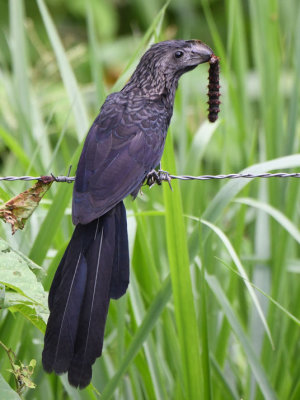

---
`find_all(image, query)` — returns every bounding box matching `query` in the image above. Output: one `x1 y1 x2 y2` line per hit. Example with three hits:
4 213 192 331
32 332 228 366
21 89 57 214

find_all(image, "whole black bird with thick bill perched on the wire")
42 40 213 388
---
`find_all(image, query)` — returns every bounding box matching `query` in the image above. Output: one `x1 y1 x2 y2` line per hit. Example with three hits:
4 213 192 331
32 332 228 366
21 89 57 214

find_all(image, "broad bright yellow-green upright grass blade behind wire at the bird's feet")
162 130 202 399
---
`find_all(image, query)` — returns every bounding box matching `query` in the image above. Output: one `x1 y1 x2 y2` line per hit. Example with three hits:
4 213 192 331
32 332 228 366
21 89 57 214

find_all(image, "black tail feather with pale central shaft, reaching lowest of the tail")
68 213 115 388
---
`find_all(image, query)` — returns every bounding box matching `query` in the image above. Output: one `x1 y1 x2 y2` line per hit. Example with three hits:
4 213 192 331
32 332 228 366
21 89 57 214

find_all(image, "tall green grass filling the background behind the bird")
0 0 300 400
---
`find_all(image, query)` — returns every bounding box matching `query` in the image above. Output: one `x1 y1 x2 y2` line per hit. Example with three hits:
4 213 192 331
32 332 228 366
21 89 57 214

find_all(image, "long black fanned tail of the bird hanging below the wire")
43 202 129 388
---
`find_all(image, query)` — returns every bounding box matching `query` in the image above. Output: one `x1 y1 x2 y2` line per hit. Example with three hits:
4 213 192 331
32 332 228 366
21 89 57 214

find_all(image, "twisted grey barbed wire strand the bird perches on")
0 171 300 185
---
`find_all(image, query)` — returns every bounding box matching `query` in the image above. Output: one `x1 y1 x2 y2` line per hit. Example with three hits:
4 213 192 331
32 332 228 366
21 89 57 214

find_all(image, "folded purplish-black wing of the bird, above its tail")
72 94 168 224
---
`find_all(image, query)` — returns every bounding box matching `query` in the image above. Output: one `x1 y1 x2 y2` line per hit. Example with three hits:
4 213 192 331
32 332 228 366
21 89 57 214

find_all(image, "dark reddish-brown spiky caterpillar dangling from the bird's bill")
207 54 221 122
